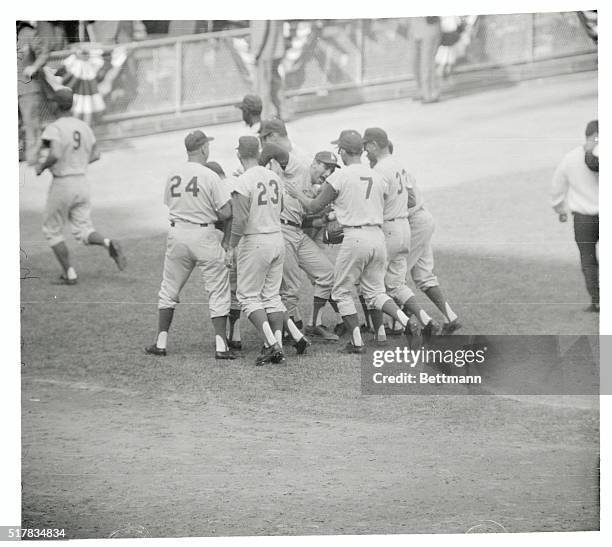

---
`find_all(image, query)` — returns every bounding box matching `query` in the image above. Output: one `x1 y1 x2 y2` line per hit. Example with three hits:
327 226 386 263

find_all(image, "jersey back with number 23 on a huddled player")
234 165 284 235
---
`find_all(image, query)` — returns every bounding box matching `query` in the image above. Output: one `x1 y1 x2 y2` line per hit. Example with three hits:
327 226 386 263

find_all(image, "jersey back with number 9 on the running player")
41 116 96 177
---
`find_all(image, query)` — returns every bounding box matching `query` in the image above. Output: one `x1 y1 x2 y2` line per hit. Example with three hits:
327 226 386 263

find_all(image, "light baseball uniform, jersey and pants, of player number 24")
158 162 231 317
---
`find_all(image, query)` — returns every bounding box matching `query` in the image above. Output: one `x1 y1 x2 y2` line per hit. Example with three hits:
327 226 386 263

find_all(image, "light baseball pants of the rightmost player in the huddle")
407 208 439 296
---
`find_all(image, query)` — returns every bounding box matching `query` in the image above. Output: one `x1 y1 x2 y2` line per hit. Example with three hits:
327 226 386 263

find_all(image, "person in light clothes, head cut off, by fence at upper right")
410 17 442 104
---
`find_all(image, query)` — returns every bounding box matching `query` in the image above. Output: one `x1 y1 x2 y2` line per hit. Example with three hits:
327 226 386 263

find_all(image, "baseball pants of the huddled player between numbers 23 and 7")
280 224 334 317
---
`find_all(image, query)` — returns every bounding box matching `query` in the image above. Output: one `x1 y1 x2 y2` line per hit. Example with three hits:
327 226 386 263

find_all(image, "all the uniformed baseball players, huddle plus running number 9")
36 90 461 365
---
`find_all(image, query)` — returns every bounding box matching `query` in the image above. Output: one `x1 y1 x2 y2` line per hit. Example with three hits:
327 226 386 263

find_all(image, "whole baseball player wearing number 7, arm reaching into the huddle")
287 129 412 353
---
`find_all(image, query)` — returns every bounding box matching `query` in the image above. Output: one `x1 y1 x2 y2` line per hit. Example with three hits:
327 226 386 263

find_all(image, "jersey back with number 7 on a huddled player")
327 163 386 226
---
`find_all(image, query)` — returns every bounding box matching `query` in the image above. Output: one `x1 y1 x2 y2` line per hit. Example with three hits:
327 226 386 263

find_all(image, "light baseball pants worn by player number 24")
158 222 230 317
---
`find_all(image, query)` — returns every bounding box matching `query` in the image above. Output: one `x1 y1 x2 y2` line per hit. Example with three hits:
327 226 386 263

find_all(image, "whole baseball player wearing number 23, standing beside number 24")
226 136 286 365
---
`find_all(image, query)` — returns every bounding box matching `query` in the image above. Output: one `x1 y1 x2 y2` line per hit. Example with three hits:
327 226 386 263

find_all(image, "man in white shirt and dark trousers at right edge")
552 120 599 312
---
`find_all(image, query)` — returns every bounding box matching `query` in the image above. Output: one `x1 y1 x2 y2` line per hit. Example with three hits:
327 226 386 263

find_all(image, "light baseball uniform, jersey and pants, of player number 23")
235 166 285 316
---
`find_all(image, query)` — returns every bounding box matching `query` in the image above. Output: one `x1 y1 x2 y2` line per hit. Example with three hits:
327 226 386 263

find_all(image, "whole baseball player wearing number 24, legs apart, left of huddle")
145 131 235 359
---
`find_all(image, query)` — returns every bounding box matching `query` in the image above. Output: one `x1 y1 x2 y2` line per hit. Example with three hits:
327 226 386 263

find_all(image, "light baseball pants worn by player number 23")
236 232 285 316
